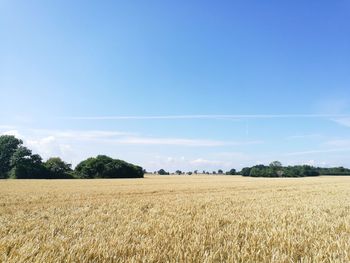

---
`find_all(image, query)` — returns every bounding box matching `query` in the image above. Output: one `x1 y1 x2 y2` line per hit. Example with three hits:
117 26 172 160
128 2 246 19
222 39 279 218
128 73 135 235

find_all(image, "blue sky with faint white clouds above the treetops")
0 0 350 171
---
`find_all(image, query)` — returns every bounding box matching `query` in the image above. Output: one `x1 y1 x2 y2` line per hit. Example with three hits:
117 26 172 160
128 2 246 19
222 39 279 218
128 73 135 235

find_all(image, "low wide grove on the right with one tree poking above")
240 161 320 177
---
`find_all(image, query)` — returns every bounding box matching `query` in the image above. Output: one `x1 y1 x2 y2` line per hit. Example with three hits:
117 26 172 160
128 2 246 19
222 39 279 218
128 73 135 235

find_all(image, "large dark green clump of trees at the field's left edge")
0 135 144 179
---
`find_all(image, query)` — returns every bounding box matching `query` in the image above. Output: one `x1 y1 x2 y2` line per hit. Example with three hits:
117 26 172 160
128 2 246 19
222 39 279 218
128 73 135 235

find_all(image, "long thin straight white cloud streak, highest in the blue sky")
62 114 350 120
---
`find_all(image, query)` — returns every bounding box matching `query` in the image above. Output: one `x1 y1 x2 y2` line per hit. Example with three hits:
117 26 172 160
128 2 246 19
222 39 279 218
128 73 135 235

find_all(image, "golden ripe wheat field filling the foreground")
0 176 350 262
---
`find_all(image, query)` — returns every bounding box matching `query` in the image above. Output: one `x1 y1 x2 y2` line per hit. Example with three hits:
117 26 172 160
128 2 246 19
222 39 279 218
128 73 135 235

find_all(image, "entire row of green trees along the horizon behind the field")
0 135 350 179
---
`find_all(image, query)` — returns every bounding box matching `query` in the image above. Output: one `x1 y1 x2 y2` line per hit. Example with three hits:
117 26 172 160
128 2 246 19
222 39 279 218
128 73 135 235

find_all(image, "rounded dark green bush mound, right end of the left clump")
74 155 144 178
